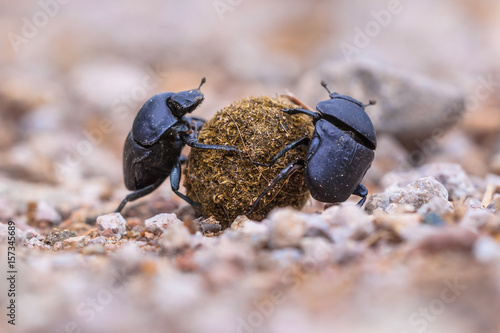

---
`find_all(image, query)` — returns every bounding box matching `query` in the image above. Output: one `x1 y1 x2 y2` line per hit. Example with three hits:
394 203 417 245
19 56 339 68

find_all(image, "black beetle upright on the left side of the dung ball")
115 78 238 212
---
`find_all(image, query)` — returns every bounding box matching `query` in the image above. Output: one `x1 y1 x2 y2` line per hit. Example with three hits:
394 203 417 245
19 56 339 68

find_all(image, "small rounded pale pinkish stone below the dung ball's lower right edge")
263 208 307 248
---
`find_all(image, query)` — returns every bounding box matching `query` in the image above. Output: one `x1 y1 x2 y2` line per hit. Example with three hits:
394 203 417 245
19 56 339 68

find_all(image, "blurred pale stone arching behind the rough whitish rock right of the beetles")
381 163 478 201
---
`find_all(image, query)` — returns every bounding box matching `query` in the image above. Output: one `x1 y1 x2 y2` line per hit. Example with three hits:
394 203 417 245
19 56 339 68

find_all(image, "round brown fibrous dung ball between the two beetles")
184 97 313 227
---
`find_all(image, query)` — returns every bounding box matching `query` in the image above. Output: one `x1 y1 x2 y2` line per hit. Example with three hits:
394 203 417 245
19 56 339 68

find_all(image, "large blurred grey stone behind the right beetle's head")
297 61 465 149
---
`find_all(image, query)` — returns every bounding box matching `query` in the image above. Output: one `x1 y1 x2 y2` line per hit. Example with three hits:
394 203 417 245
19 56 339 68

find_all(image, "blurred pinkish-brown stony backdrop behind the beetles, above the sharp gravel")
0 0 500 213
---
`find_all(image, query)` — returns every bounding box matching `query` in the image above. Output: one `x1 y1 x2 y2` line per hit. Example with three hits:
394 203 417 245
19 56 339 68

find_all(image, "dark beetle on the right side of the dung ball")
247 81 377 215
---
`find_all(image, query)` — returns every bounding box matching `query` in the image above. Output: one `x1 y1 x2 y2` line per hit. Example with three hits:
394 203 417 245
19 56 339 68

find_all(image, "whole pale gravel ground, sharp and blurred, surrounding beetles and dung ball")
0 0 500 333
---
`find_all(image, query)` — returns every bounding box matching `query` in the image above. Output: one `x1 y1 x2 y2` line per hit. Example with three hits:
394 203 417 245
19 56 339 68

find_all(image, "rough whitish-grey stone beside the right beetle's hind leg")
365 177 453 213
